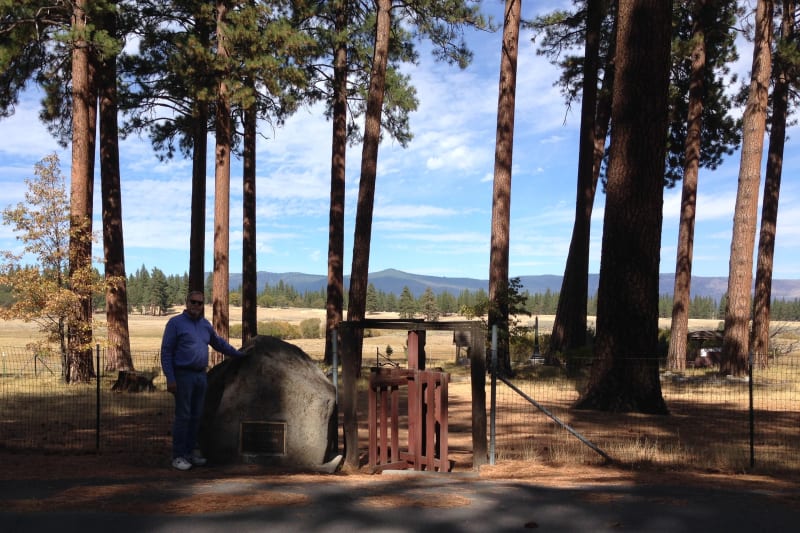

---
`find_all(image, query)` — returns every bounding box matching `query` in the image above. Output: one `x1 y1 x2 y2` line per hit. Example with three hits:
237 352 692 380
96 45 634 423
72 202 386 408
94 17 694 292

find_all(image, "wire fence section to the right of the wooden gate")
492 355 800 473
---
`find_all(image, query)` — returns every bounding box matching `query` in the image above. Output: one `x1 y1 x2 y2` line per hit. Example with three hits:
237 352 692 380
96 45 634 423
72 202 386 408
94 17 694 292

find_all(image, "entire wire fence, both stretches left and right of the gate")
6 340 800 473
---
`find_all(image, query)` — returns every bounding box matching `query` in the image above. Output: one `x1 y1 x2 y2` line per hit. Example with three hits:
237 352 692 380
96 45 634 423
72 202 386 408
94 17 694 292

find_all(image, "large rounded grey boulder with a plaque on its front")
199 336 340 470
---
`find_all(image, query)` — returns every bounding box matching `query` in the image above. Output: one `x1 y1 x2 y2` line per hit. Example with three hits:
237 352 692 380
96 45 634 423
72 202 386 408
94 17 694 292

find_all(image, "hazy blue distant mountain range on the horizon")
230 269 800 300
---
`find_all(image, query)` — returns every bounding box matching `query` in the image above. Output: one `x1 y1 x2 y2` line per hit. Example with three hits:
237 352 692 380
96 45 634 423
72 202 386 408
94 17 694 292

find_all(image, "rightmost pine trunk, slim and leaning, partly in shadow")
752 0 797 368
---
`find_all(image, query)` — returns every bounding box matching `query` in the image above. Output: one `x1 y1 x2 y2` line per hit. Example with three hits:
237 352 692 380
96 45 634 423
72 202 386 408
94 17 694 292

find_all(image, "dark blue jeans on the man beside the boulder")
172 369 208 459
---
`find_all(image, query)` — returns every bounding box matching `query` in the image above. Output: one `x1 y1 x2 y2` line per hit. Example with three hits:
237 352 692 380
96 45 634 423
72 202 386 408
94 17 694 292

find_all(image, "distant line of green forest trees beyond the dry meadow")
114 266 800 320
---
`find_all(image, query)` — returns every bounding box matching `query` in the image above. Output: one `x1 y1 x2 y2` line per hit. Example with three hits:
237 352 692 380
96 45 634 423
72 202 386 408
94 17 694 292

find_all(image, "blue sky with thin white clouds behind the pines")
0 0 800 279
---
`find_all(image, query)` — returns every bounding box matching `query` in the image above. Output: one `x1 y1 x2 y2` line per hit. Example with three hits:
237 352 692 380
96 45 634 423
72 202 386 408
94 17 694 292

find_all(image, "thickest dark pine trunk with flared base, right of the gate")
576 0 671 414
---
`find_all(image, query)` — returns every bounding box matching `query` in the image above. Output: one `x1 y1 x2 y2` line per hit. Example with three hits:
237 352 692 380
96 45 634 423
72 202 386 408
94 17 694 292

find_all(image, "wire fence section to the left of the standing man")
0 347 174 456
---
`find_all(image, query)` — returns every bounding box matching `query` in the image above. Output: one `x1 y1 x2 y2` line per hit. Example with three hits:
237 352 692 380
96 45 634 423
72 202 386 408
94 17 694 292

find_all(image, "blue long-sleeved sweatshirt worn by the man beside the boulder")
161 311 244 383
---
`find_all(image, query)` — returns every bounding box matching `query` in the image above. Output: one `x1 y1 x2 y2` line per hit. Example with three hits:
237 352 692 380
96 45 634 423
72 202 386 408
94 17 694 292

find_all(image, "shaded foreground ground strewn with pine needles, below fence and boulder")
0 452 800 533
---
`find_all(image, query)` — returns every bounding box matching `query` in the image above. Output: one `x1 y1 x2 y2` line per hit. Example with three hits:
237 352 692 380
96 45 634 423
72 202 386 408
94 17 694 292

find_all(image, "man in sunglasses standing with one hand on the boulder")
161 291 244 470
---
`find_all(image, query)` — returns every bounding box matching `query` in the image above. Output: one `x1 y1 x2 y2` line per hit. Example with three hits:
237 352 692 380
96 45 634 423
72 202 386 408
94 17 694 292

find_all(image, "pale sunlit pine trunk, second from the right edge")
720 0 773 376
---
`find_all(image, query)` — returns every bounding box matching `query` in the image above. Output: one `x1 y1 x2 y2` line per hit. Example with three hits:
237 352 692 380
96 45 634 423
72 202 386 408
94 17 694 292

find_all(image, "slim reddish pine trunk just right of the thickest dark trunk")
667 0 706 370
